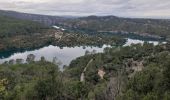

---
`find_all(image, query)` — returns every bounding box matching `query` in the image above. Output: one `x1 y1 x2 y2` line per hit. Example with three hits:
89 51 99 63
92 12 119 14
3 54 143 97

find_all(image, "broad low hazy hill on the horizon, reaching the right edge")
59 16 170 36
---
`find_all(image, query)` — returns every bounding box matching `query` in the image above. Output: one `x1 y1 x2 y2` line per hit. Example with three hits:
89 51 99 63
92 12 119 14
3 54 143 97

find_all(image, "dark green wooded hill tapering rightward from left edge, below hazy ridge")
0 15 47 38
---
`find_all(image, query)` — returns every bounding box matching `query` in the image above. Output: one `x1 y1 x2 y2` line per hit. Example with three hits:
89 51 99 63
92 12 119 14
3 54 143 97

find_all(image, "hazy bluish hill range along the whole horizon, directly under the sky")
0 10 170 38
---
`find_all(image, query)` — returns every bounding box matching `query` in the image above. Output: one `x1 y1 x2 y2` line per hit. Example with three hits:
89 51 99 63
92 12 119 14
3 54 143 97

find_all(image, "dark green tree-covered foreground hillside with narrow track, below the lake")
0 43 170 100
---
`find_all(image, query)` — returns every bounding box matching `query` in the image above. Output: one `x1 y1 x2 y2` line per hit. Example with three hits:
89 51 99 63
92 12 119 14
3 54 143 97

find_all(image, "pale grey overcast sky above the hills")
0 0 170 18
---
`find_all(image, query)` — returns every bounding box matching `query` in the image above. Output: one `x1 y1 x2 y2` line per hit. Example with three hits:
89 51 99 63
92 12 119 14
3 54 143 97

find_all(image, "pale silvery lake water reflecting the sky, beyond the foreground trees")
0 38 165 68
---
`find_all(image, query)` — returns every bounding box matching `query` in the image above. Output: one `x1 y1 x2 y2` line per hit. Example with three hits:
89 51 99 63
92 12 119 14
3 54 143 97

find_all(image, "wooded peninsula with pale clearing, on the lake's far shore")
0 29 126 53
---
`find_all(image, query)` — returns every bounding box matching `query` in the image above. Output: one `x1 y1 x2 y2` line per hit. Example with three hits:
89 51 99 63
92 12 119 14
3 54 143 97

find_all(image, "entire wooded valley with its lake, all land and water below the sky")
0 10 170 100
